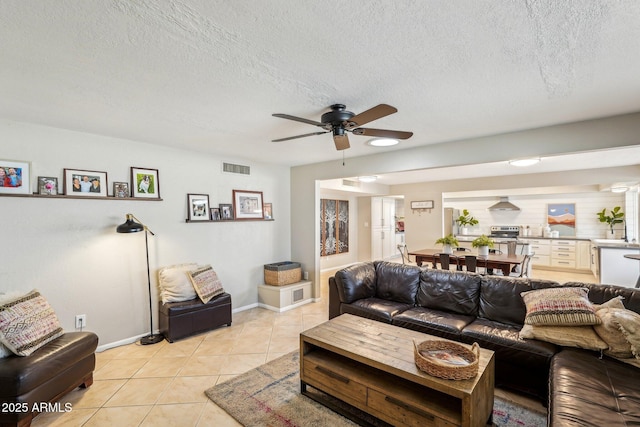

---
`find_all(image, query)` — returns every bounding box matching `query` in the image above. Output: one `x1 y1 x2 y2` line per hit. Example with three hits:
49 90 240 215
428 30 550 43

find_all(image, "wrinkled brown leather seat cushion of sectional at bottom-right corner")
549 348 640 427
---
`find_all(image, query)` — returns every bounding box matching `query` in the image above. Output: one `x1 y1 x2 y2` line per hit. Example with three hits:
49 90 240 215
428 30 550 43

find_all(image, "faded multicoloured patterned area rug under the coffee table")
205 351 547 427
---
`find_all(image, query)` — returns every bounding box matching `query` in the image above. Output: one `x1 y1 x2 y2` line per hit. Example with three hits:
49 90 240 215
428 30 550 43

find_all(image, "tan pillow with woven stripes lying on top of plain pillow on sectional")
520 287 601 326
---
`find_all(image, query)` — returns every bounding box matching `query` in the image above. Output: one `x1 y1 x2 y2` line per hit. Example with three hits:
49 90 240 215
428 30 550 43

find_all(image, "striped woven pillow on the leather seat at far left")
0 290 64 356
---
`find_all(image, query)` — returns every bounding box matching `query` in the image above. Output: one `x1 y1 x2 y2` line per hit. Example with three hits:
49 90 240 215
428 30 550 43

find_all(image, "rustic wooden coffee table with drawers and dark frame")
300 314 494 426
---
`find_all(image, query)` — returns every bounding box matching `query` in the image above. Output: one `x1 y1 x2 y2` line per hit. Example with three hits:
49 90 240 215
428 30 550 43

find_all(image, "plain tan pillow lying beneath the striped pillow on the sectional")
520 325 609 350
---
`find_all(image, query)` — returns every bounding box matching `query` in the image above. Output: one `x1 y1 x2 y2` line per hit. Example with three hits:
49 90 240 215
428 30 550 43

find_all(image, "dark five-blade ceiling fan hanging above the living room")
272 104 413 150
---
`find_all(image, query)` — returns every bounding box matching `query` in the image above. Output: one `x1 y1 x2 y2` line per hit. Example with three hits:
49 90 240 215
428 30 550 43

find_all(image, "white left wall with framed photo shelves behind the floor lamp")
0 121 291 346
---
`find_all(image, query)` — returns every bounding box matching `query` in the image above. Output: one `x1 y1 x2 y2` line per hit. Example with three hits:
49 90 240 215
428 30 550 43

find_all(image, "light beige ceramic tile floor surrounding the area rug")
32 270 593 427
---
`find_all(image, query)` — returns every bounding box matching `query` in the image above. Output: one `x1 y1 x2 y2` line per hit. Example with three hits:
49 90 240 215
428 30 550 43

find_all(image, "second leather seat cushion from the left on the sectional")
392 307 475 339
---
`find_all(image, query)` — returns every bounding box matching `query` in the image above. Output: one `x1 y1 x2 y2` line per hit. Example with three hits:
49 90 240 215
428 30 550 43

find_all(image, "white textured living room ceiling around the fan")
0 0 640 169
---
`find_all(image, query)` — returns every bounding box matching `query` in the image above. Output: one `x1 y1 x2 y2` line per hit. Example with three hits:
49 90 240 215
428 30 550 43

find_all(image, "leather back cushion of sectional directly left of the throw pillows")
478 276 531 327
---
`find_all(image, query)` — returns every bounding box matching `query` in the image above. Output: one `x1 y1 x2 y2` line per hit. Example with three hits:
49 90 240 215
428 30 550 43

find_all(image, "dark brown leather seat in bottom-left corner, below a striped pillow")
0 332 98 426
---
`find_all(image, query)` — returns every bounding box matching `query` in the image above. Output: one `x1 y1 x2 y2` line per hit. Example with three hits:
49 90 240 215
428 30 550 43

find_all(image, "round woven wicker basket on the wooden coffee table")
413 340 480 380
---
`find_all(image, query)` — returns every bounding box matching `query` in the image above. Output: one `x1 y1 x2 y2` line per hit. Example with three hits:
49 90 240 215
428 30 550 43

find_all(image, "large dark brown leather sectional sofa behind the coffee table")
329 261 640 425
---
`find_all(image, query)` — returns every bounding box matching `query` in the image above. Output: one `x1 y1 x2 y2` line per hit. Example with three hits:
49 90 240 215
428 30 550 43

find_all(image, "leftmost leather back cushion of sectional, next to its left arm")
374 261 421 305
